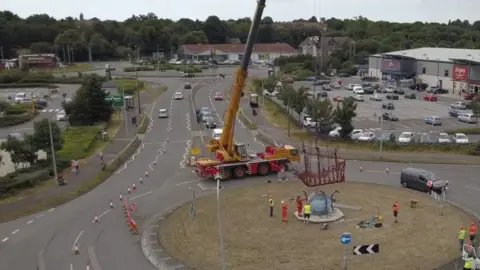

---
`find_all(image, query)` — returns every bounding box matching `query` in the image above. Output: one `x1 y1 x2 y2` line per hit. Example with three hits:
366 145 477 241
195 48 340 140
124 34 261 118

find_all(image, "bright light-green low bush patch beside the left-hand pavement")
57 126 100 160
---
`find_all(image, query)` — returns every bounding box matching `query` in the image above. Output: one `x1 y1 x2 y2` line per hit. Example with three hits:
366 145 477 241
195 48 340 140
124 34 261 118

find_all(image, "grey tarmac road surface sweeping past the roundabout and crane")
0 68 480 270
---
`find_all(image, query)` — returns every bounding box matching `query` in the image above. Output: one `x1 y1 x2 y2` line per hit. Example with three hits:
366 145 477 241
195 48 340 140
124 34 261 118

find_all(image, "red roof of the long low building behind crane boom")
182 43 297 54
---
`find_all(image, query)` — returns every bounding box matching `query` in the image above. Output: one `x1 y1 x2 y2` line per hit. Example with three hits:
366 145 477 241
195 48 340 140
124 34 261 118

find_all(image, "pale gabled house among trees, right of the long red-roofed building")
298 36 350 70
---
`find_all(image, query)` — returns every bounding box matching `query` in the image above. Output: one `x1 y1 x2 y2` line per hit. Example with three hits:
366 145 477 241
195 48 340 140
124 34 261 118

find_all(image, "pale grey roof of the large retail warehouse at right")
373 47 480 63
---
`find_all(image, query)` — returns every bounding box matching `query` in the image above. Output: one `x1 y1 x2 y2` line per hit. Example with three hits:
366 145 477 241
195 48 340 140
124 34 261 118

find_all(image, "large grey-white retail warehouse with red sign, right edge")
368 47 480 93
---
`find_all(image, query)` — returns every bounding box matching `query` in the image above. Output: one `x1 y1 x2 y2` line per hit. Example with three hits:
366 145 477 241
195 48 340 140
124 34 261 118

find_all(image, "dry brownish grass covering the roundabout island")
159 182 471 270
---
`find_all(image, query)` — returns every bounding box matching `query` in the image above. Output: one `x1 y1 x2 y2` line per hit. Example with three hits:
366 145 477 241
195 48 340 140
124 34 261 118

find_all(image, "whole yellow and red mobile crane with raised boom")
196 0 300 180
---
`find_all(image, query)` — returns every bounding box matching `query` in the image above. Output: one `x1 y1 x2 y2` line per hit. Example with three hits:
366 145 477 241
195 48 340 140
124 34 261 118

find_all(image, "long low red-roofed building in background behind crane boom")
177 43 298 62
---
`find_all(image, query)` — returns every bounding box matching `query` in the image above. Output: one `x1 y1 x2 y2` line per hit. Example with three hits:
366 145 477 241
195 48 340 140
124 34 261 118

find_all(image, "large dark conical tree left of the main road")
63 75 113 126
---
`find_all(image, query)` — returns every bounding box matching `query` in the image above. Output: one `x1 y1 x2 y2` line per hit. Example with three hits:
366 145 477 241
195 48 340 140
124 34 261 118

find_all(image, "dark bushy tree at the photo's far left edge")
0 136 38 170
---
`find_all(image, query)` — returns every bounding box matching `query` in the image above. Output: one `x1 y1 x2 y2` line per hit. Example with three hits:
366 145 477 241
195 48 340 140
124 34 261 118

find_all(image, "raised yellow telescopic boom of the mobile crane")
207 0 266 162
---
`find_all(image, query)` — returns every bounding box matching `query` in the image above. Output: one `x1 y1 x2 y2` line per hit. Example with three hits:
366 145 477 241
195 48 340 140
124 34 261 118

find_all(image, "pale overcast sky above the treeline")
0 0 480 22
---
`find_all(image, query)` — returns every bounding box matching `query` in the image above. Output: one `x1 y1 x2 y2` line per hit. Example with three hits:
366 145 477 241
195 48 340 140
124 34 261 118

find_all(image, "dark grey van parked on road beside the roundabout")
400 168 447 192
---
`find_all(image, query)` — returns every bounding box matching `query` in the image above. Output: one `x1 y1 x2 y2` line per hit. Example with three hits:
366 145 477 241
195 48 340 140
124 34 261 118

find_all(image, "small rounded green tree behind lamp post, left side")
29 119 63 159
